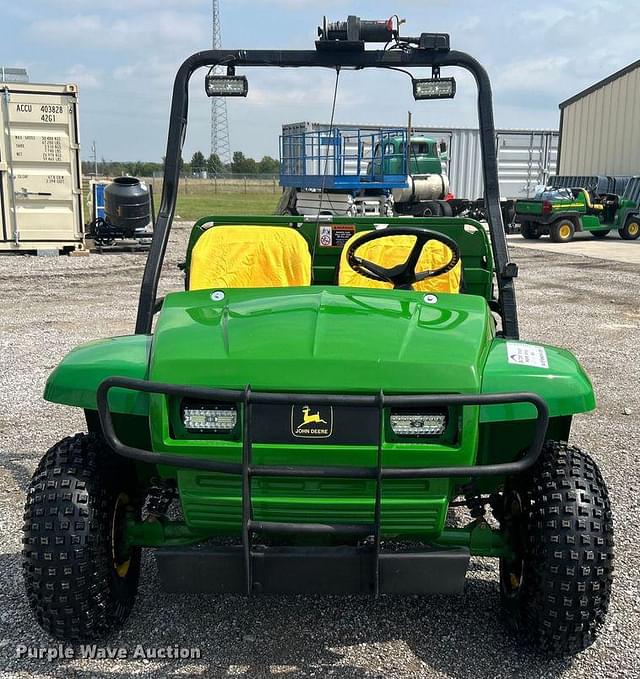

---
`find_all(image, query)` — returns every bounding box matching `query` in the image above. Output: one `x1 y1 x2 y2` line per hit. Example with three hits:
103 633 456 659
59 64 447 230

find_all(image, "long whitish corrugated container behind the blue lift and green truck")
282 122 558 200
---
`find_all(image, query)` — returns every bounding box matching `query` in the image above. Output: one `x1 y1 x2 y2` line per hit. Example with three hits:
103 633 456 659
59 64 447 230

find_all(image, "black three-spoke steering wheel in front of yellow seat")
347 226 460 290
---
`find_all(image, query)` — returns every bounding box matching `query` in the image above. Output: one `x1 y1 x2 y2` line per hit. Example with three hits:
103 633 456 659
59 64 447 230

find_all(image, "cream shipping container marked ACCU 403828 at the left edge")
0 83 84 251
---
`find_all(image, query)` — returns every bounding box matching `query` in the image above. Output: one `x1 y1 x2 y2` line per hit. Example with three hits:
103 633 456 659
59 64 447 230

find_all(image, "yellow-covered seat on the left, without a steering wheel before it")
189 226 311 290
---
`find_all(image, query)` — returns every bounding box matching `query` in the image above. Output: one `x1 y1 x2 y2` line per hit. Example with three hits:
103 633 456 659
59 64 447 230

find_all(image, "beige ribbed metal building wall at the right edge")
558 60 640 175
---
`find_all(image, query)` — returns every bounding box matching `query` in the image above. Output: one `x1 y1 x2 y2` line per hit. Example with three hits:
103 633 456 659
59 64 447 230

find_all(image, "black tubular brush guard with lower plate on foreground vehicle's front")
97 377 549 595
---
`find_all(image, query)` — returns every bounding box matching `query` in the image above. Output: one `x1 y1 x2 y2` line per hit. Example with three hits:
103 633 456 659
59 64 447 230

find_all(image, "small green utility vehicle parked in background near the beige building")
516 177 640 243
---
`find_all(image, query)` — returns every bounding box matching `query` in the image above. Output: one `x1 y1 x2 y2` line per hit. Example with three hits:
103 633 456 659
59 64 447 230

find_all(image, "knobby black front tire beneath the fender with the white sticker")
500 442 613 656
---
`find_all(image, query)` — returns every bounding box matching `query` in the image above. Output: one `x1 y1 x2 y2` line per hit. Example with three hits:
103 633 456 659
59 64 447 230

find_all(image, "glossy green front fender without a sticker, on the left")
44 335 152 415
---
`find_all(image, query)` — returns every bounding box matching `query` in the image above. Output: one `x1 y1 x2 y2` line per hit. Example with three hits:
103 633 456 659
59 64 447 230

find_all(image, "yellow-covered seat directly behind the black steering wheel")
338 231 462 293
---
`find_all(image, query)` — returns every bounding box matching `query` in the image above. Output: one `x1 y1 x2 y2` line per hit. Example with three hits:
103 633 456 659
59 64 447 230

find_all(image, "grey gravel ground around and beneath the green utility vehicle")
0 228 640 679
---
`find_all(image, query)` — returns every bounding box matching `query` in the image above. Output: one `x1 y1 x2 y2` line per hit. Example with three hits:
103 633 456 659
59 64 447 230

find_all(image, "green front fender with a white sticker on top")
480 339 596 422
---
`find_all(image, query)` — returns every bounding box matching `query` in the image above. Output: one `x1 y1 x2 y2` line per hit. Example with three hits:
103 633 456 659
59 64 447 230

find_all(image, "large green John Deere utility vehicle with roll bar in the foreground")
23 17 613 655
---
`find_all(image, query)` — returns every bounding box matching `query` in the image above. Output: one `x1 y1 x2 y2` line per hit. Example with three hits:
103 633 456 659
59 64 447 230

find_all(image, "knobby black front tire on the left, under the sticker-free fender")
22 434 140 641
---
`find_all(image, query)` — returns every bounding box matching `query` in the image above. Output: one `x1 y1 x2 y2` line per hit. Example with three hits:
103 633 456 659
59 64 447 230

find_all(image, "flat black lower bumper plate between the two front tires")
156 546 469 594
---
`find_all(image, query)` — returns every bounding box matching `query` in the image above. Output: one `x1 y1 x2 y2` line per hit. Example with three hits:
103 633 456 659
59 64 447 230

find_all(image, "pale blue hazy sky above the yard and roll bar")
0 0 640 160
